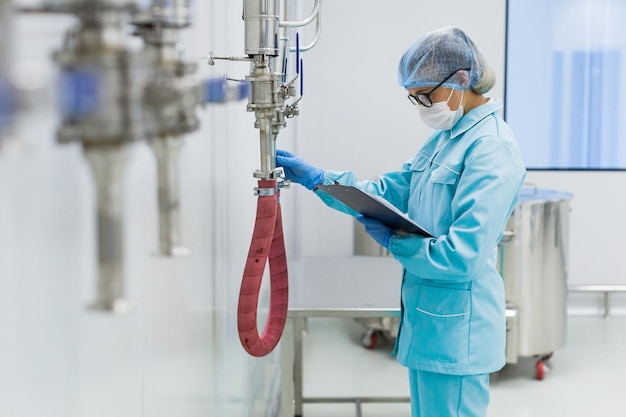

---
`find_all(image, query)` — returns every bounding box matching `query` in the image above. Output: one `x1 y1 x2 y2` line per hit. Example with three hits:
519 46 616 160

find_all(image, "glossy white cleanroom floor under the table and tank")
296 317 626 417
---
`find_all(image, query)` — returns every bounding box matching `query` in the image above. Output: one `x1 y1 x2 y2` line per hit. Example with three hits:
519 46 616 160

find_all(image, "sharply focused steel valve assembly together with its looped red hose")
209 0 320 356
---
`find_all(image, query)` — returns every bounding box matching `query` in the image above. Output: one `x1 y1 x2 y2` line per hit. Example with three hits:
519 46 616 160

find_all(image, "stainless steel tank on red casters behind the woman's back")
498 188 572 366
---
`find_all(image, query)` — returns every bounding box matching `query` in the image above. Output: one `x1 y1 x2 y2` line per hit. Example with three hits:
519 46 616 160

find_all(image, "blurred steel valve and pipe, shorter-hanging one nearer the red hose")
133 0 197 256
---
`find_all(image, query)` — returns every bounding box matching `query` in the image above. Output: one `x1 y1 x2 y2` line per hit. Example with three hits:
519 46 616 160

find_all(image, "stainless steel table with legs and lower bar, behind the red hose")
278 256 410 417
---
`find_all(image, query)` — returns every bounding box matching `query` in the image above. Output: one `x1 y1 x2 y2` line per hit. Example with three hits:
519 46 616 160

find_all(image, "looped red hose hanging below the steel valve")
237 180 289 357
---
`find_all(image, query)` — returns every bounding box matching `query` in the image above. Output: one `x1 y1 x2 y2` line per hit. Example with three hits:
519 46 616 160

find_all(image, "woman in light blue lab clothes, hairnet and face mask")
277 27 526 417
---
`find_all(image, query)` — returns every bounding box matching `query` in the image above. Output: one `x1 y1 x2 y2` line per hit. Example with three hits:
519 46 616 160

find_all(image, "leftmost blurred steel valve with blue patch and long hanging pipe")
54 0 157 313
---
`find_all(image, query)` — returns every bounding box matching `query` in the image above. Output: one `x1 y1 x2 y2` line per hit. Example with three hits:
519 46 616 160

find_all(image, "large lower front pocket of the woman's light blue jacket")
411 285 471 363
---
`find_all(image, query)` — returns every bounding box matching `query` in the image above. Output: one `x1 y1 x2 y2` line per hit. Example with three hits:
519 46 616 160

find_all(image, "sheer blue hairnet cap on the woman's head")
398 26 495 94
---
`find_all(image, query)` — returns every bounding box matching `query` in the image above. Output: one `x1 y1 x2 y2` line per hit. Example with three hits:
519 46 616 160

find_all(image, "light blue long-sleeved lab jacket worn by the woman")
316 99 526 375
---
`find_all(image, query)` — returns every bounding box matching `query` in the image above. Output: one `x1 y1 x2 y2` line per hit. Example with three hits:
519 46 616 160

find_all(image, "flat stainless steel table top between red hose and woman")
288 256 402 318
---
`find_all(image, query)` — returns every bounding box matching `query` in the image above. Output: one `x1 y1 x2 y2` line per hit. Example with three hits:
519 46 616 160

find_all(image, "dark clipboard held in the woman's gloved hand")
316 184 433 237
